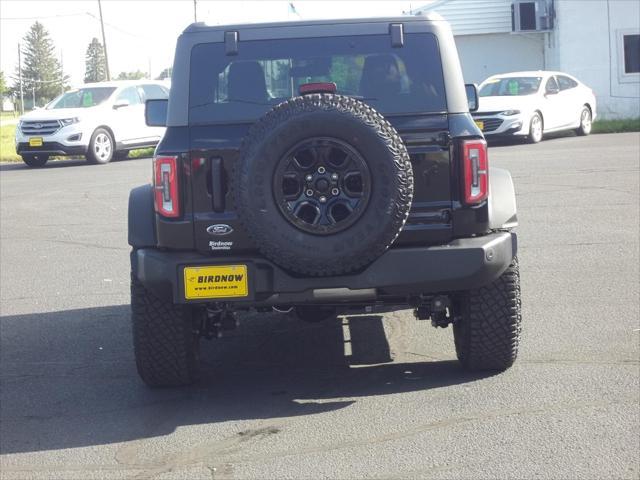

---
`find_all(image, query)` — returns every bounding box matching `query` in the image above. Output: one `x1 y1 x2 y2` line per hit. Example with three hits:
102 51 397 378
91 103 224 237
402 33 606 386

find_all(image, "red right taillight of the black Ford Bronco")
462 140 489 205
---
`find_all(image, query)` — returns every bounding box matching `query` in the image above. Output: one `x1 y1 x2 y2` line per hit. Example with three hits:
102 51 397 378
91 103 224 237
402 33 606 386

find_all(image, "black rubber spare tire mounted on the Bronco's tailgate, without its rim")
231 94 413 276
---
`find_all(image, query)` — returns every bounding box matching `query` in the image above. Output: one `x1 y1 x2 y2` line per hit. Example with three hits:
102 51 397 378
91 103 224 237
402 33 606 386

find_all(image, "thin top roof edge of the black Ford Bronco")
183 12 444 33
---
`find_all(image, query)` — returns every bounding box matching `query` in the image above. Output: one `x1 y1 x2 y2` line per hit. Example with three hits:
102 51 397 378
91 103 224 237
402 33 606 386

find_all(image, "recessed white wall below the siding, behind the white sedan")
455 33 544 83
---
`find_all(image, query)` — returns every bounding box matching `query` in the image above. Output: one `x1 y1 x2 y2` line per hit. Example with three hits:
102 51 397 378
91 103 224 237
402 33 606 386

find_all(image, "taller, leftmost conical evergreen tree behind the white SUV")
12 22 69 105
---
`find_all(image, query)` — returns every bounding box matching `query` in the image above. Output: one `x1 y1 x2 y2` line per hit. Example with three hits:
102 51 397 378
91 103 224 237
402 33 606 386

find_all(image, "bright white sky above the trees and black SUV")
0 0 422 85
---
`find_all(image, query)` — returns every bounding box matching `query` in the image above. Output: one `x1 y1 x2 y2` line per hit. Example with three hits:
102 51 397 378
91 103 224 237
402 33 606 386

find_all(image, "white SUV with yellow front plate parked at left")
16 80 169 167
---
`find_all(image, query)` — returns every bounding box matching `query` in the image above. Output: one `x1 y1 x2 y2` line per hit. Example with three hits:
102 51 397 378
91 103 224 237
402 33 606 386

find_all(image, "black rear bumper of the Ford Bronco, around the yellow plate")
131 232 517 306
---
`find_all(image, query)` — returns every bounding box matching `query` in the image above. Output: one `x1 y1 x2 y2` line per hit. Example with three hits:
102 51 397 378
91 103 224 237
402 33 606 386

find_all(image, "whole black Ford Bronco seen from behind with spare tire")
129 16 521 386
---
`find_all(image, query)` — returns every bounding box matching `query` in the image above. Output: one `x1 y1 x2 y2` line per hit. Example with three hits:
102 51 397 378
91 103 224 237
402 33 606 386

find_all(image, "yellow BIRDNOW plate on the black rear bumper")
184 265 249 300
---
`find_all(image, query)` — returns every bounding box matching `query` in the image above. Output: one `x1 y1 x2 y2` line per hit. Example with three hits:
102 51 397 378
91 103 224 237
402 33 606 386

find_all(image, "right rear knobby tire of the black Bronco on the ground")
453 258 522 371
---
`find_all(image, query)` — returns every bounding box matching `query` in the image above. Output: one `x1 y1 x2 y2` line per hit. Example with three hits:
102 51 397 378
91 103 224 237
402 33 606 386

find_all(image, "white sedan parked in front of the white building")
473 71 596 143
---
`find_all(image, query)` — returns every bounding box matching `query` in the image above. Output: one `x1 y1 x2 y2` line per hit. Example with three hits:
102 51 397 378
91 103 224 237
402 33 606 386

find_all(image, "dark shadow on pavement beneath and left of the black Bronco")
0 305 486 454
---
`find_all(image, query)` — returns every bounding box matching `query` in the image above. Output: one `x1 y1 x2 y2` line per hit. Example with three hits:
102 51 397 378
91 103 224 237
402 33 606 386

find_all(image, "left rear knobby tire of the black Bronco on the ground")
131 273 198 387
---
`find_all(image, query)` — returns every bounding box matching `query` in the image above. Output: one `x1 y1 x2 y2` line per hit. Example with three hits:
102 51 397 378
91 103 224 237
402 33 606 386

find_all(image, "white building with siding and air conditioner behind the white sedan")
412 0 640 118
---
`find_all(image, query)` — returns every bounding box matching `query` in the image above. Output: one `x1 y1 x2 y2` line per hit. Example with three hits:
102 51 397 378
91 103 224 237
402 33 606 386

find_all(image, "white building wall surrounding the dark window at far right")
545 0 640 118
